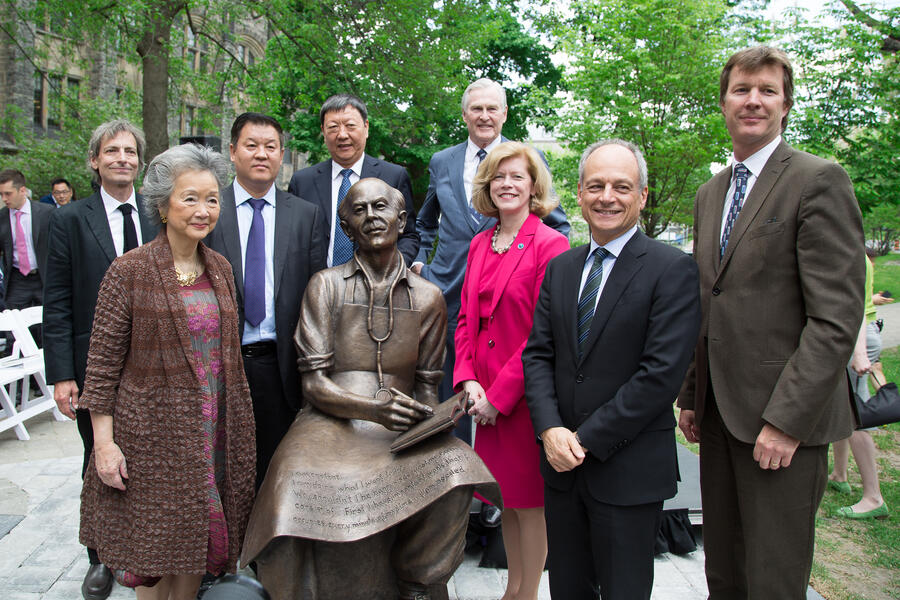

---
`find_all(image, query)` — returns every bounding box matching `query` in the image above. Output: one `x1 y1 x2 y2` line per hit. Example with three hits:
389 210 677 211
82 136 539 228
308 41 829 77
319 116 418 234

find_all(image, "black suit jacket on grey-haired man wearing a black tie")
43 193 158 390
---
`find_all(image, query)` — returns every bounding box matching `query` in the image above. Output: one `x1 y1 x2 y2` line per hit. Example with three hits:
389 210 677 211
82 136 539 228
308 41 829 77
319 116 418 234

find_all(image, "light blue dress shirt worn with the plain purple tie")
233 179 275 344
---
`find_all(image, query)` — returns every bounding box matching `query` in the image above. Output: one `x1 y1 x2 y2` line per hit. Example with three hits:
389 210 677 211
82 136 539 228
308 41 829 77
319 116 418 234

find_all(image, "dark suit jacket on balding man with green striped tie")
522 231 700 506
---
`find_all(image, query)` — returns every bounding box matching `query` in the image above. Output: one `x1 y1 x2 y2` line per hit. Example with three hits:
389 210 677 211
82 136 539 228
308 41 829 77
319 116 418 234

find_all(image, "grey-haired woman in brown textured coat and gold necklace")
80 144 256 600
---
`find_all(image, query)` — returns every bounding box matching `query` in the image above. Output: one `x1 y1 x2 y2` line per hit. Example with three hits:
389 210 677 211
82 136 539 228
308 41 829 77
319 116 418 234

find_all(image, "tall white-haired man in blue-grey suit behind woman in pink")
412 78 570 443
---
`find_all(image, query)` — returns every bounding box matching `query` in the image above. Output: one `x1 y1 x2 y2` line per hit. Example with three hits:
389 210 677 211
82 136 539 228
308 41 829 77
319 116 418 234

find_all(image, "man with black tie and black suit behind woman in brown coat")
43 120 157 600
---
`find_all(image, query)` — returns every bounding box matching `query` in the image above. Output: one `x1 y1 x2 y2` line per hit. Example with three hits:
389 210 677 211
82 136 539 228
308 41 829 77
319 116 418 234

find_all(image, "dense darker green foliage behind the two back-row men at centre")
249 0 560 203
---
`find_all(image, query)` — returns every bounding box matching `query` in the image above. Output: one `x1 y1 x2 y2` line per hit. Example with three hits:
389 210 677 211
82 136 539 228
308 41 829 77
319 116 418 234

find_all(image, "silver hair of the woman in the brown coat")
141 144 228 225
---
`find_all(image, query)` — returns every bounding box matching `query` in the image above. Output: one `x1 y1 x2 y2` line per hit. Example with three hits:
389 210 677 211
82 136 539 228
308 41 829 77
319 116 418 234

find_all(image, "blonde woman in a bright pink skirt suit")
453 142 569 600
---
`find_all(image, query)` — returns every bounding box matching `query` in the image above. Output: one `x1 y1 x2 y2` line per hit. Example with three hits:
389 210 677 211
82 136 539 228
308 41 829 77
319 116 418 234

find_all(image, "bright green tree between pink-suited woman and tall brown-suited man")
543 0 729 236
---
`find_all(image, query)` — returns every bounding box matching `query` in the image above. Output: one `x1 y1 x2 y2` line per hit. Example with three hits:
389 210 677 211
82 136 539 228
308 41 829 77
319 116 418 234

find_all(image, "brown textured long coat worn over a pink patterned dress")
80 229 256 576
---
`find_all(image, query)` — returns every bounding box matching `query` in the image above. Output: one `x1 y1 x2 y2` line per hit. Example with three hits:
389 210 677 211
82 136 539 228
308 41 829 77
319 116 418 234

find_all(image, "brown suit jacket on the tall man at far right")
678 142 865 445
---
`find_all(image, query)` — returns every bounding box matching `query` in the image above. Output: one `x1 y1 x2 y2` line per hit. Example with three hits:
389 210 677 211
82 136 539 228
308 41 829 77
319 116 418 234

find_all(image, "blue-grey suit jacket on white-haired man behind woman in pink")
415 138 570 335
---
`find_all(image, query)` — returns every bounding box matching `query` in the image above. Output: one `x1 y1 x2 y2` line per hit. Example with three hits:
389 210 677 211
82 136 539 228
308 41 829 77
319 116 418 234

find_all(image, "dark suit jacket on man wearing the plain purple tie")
206 185 328 410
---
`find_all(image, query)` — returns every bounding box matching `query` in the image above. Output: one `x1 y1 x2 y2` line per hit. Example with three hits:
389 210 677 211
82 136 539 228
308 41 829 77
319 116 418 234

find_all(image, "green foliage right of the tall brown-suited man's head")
776 4 900 212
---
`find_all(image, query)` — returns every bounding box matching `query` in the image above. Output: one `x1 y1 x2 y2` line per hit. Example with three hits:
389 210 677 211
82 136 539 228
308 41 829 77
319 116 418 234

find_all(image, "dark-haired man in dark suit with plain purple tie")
206 113 327 489
